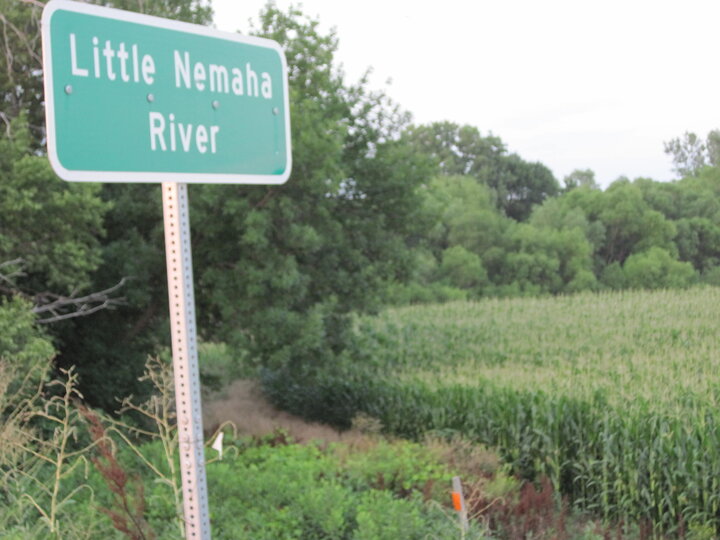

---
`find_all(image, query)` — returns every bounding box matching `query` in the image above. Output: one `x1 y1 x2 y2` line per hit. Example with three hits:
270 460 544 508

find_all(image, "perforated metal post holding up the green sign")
162 183 210 540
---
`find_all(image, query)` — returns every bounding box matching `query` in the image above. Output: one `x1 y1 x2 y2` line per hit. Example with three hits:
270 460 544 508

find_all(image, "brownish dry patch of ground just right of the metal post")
203 379 361 442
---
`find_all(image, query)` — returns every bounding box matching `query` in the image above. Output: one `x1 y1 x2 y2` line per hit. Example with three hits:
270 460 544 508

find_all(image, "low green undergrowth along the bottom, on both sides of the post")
0 420 485 540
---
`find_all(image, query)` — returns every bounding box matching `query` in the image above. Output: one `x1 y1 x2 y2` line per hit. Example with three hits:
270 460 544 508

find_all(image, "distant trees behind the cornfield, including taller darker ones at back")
389 123 720 303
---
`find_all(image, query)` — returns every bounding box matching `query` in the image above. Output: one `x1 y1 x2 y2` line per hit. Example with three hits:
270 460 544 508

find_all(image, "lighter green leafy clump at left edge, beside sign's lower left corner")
0 115 109 294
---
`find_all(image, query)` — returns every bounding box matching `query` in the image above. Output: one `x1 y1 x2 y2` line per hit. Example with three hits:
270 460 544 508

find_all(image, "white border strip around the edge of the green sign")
41 0 292 185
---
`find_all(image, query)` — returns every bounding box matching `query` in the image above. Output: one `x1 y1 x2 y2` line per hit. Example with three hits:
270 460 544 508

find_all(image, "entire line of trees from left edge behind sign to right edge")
0 0 720 410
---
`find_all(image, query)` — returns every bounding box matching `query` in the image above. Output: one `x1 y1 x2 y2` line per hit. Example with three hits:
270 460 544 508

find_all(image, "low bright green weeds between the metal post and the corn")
208 441 480 540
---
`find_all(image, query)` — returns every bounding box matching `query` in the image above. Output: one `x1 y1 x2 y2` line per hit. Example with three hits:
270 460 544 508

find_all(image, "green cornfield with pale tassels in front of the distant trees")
264 288 720 535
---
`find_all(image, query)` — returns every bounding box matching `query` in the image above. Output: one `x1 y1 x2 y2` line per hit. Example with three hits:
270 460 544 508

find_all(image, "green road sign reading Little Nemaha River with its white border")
42 0 291 184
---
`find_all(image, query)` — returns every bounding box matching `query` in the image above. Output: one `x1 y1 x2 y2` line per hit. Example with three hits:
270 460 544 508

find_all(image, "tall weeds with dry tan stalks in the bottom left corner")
0 362 97 539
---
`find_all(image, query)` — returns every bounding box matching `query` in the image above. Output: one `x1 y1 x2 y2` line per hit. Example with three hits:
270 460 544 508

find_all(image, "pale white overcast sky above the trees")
212 0 720 186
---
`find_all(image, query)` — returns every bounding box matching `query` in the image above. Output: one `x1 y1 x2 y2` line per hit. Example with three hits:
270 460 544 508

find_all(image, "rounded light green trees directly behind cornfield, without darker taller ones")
396 167 720 305
